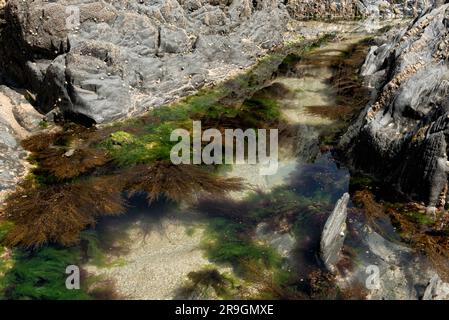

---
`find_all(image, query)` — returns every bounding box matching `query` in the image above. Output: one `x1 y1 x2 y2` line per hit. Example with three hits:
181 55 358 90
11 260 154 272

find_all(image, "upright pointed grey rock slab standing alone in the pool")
320 193 349 272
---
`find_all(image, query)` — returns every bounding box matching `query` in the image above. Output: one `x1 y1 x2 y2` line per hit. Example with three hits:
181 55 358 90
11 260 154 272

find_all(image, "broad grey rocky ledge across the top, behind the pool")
0 0 433 124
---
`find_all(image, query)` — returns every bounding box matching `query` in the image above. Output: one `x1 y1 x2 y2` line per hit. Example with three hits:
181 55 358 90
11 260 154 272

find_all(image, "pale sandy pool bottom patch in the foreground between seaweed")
85 218 210 300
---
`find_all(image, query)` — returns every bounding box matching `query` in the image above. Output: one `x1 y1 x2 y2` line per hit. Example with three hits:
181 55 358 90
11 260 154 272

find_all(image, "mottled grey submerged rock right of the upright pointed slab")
336 222 434 300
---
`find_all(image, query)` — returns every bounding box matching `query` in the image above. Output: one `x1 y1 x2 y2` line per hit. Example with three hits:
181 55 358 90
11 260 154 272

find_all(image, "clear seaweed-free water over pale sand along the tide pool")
86 30 420 299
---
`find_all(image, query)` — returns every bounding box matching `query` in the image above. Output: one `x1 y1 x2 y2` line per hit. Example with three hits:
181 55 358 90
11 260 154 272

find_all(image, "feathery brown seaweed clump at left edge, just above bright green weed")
3 177 125 247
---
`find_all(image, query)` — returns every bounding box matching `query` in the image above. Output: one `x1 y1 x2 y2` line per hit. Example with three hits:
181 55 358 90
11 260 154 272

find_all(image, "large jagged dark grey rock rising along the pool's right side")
340 5 449 206
